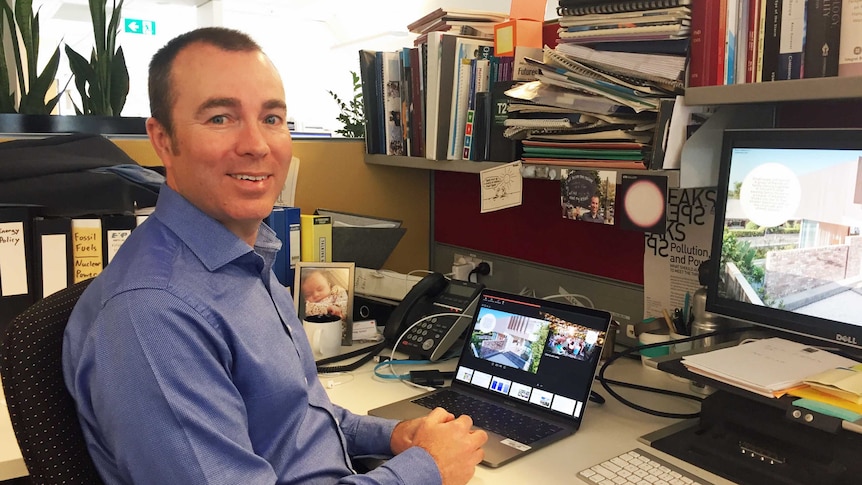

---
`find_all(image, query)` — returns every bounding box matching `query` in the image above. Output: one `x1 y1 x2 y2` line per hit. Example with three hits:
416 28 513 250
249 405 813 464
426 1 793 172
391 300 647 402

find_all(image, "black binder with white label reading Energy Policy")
0 205 35 335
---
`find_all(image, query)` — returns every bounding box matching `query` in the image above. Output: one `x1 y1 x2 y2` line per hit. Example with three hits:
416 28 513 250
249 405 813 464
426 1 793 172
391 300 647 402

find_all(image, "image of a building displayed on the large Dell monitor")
718 148 862 325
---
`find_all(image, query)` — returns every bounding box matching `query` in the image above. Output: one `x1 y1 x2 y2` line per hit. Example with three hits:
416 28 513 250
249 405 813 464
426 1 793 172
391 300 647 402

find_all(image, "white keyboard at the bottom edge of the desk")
578 448 712 485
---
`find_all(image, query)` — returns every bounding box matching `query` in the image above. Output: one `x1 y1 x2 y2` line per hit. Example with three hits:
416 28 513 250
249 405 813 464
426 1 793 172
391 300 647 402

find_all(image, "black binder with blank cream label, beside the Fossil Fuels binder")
32 217 72 300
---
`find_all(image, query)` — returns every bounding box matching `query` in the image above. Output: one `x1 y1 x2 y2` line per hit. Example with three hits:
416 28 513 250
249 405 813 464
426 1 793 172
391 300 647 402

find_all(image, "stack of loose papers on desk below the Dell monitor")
682 338 857 397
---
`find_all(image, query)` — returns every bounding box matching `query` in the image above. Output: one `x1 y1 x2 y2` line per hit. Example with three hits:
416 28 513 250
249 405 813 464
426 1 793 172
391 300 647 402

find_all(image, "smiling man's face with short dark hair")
147 43 292 244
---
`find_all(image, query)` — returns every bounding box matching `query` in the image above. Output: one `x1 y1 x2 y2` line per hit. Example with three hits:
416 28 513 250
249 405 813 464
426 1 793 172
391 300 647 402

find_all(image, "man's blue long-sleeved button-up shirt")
63 186 440 485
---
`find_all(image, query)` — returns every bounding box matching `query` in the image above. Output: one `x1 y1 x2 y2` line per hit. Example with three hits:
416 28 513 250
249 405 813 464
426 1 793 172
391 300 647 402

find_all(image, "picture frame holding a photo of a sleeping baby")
293 261 356 345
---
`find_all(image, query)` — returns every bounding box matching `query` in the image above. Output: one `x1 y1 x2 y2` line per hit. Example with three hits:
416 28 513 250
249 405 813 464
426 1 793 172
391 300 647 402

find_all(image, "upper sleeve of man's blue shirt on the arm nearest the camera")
77 290 276 484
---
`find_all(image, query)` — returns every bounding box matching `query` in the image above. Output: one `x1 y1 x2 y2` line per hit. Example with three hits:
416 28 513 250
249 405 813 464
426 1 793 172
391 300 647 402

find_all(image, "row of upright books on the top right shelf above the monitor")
688 0 862 87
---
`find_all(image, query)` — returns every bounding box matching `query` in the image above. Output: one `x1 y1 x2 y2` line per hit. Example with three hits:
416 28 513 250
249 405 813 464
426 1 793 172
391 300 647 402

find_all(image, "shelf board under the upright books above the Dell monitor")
685 77 862 106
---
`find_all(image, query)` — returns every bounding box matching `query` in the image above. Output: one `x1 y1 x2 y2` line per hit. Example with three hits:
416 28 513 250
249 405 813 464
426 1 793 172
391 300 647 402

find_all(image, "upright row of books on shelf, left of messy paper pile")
359 9 515 161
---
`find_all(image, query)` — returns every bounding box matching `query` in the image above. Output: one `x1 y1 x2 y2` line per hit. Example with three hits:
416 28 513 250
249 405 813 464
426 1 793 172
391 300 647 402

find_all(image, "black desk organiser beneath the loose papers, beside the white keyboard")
644 359 862 485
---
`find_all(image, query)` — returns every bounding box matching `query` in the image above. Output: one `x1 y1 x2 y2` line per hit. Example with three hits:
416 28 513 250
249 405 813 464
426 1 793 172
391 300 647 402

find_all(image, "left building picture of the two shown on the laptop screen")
470 308 548 374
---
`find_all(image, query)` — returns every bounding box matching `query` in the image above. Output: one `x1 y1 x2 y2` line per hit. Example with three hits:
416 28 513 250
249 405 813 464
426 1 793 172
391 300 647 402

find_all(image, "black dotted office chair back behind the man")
0 280 103 485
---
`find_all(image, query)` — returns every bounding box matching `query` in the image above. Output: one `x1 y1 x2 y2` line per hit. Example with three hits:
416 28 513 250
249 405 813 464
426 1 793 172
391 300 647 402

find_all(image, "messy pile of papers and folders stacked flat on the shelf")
506 39 685 169
